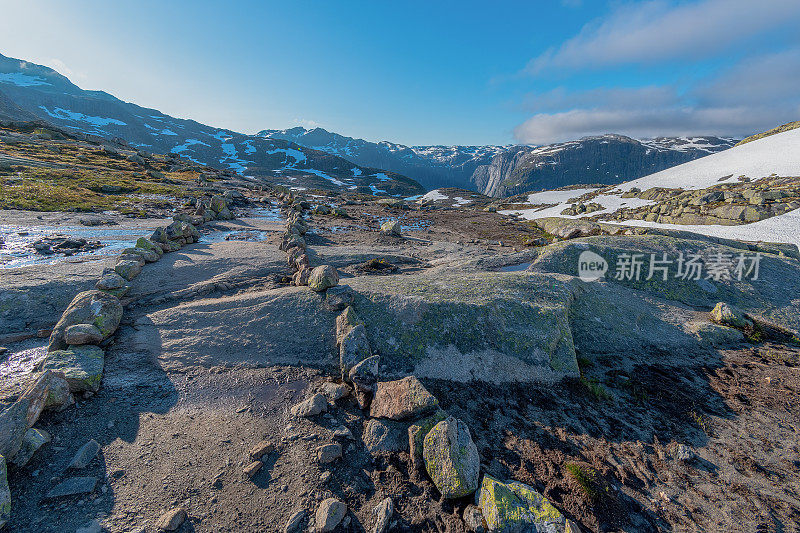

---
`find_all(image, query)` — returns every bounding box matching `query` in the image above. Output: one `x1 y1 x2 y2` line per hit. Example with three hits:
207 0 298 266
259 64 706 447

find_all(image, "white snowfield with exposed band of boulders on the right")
500 129 800 246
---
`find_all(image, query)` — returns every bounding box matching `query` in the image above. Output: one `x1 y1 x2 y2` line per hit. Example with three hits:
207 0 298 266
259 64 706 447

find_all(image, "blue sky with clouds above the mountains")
0 0 800 144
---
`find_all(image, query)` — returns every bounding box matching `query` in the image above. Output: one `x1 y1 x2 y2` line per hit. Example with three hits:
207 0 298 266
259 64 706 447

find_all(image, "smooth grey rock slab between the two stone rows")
134 286 336 370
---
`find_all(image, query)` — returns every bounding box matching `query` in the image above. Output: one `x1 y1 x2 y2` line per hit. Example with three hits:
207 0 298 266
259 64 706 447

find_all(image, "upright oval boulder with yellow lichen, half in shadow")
422 417 481 499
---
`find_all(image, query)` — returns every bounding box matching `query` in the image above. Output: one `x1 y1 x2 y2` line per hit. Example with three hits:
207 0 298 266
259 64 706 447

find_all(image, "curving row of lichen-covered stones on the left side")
0 191 241 529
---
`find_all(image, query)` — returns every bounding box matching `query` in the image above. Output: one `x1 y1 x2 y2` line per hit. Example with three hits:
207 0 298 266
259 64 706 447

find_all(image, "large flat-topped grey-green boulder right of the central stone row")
348 269 579 383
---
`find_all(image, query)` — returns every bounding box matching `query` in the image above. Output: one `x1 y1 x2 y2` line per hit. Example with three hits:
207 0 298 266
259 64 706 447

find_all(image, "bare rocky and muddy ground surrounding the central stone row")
0 181 800 532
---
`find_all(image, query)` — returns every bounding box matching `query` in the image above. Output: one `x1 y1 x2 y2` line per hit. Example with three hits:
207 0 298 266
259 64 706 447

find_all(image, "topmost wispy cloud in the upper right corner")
526 0 800 74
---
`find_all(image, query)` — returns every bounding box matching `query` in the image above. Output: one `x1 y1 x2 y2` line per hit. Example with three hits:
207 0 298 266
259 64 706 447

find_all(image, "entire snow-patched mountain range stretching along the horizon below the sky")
0 55 736 197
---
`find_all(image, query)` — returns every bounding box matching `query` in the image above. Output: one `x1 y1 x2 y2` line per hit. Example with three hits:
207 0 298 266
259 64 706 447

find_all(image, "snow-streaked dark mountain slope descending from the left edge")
0 55 423 196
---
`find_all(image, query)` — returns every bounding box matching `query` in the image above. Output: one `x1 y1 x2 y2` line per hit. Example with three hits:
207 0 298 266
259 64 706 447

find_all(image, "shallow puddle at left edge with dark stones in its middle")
0 225 159 268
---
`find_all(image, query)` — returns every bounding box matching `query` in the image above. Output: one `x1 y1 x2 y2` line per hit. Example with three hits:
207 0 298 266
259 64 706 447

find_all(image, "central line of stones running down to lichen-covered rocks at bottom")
276 191 580 533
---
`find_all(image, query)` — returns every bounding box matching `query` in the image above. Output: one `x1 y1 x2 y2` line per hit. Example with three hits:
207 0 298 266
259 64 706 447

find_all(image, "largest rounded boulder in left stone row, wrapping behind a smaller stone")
47 290 122 352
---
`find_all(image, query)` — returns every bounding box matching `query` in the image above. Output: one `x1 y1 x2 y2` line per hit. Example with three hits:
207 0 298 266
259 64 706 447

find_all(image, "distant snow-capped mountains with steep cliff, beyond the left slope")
257 127 735 197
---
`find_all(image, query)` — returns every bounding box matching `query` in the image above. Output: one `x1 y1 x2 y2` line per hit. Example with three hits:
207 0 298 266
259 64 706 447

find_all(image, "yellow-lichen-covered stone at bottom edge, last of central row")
476 474 567 532
